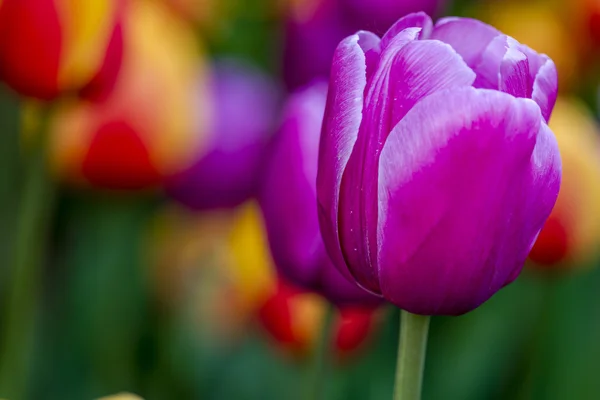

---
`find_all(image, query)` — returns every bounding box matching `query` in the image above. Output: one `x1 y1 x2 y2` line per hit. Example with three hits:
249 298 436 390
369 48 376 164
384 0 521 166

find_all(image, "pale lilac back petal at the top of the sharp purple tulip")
431 17 500 67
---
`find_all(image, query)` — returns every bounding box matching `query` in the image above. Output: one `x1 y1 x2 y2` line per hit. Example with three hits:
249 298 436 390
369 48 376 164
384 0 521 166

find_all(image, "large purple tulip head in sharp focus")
317 13 561 315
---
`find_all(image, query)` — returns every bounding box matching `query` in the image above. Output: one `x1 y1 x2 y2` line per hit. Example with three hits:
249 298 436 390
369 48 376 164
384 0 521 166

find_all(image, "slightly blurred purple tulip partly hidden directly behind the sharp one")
259 82 378 305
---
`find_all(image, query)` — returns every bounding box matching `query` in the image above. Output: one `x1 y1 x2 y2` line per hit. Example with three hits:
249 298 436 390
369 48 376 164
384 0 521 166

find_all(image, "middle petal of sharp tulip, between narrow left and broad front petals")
339 37 475 293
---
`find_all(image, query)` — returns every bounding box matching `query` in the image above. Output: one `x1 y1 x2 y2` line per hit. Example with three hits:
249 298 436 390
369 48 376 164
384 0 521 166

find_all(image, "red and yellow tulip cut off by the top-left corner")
0 0 125 100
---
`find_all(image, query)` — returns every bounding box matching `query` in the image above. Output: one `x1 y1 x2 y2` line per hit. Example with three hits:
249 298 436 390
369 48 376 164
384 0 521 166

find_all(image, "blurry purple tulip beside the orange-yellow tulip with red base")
166 61 279 210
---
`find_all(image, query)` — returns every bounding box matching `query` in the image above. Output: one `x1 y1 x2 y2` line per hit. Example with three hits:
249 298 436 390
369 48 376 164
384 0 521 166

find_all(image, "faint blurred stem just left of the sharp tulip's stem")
307 302 335 400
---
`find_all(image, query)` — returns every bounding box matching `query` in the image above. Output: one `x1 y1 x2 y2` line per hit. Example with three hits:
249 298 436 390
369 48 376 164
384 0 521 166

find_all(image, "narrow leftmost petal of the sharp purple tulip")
317 32 377 284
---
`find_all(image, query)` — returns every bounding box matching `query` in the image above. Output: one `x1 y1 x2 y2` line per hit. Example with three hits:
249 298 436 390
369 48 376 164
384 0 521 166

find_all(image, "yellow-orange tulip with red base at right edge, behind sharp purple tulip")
529 99 600 270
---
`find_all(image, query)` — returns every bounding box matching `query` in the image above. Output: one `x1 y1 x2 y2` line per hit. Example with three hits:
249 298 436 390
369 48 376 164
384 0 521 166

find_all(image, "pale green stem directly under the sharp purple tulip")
394 311 430 400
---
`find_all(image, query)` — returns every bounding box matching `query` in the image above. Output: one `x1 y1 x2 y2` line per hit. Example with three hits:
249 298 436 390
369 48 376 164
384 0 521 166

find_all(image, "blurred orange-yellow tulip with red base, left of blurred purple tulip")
49 0 206 189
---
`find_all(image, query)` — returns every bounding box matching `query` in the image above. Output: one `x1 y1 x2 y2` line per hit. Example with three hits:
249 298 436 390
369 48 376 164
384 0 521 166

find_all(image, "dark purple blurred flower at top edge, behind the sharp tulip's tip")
283 0 448 89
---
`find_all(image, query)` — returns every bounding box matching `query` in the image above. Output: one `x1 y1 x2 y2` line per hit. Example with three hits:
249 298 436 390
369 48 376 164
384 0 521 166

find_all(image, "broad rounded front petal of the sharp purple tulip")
379 88 561 315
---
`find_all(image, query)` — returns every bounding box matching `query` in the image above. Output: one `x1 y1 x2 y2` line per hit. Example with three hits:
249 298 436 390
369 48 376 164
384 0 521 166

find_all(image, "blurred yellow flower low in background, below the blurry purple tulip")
147 202 275 342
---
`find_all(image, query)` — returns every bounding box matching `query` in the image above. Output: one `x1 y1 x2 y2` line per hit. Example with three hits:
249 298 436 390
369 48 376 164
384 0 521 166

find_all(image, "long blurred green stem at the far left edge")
0 104 54 399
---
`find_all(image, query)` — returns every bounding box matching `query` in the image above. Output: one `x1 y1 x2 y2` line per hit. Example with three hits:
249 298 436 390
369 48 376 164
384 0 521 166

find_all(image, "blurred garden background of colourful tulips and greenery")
0 0 600 400
